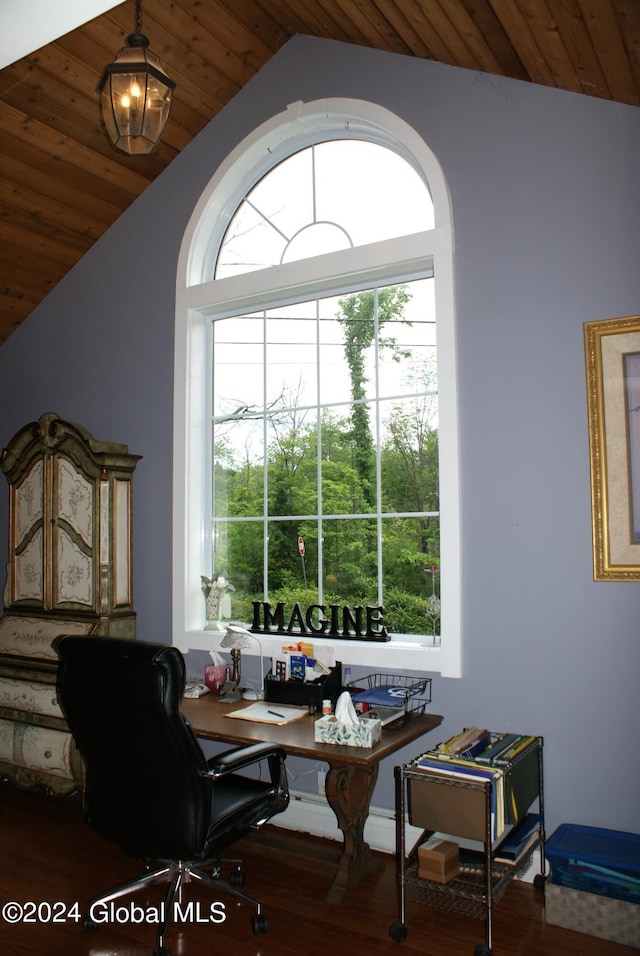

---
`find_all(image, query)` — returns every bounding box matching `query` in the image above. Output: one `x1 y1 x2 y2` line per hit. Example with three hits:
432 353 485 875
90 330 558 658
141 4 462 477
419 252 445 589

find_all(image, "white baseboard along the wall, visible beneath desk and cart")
271 790 539 883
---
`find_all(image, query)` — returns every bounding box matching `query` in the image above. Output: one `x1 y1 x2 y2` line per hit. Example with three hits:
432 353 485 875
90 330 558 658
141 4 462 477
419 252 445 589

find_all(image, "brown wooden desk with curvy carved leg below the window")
182 694 442 904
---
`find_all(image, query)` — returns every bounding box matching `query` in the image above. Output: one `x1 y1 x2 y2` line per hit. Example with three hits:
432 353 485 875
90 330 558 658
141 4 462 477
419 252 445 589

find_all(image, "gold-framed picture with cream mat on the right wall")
584 315 640 581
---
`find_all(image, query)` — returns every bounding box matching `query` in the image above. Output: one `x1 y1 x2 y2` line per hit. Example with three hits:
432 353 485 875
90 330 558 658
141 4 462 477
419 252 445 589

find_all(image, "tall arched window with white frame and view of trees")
174 101 460 676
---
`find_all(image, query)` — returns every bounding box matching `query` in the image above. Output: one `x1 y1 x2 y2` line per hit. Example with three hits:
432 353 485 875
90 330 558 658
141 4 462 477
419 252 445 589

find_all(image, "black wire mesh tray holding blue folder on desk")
347 673 431 724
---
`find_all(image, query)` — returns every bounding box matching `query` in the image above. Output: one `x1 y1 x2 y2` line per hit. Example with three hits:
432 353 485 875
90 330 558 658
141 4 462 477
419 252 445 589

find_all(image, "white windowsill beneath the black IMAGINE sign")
174 629 442 673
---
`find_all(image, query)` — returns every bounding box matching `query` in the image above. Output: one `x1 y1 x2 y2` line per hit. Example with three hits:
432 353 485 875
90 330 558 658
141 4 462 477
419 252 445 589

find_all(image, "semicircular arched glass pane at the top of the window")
215 138 433 279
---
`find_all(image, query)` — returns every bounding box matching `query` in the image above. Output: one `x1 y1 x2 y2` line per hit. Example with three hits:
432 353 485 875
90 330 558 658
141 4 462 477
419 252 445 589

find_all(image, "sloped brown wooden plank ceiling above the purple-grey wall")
0 0 640 342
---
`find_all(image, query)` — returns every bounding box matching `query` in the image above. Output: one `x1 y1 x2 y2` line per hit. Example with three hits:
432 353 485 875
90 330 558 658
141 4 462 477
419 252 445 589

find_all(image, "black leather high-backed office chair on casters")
56 636 289 956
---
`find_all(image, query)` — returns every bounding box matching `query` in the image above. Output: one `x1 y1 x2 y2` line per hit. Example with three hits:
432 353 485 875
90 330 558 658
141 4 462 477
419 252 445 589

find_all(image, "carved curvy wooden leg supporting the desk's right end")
325 763 381 904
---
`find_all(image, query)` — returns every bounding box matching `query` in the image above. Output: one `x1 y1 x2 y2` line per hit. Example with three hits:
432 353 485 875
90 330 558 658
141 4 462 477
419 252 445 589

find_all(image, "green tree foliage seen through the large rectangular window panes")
214 286 440 633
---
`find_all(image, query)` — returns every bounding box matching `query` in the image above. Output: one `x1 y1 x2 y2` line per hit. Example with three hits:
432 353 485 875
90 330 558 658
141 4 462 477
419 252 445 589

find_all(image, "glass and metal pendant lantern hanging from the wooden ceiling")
98 0 176 156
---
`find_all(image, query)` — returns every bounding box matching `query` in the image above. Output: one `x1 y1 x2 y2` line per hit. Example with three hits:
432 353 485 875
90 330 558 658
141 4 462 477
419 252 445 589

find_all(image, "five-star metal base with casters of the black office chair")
83 860 267 956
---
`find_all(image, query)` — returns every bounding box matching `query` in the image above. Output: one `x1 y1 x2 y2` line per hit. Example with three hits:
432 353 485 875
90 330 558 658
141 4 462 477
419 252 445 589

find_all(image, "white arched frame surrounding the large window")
173 99 462 677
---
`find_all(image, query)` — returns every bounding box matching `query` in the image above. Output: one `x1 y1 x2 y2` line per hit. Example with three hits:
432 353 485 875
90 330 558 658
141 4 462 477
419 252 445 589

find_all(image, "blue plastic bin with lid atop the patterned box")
545 823 640 903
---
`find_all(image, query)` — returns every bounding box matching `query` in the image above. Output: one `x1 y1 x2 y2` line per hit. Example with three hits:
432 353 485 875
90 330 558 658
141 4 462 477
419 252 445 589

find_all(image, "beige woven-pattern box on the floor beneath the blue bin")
544 881 640 949
